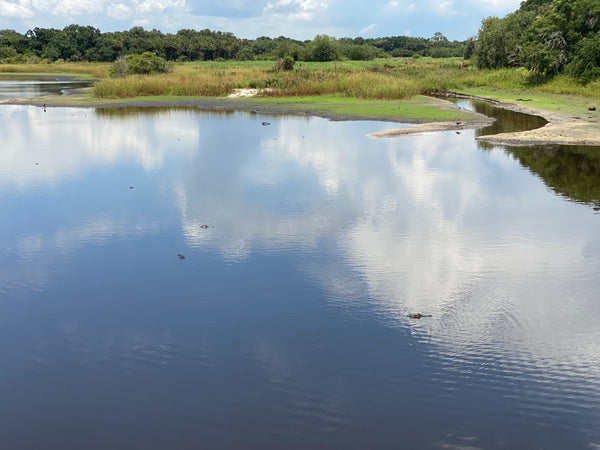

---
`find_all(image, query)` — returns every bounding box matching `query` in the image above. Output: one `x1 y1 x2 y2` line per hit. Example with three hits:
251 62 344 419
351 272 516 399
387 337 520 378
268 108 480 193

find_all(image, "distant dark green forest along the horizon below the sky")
0 25 465 63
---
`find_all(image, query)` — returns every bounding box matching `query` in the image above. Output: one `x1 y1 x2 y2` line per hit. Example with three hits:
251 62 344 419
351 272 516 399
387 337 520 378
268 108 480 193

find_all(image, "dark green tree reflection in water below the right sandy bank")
505 146 600 210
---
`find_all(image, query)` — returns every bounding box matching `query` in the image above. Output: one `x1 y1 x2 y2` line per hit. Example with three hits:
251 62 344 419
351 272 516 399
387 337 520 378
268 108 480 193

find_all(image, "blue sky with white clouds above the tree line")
0 0 520 40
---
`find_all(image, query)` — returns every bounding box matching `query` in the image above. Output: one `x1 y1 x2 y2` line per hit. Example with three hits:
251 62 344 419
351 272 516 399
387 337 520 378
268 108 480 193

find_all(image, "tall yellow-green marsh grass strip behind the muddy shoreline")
89 58 600 100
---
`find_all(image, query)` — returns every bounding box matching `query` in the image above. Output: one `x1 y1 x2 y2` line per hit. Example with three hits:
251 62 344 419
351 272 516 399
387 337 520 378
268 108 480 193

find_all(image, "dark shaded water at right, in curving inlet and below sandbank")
457 100 600 211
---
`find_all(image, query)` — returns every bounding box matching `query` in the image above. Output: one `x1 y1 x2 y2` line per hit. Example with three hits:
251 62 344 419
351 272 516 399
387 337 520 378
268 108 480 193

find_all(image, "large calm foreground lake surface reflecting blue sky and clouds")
0 82 600 449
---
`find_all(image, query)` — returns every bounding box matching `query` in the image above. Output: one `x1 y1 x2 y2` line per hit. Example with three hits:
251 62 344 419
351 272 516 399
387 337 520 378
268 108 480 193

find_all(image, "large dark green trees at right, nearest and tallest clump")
474 0 600 83
